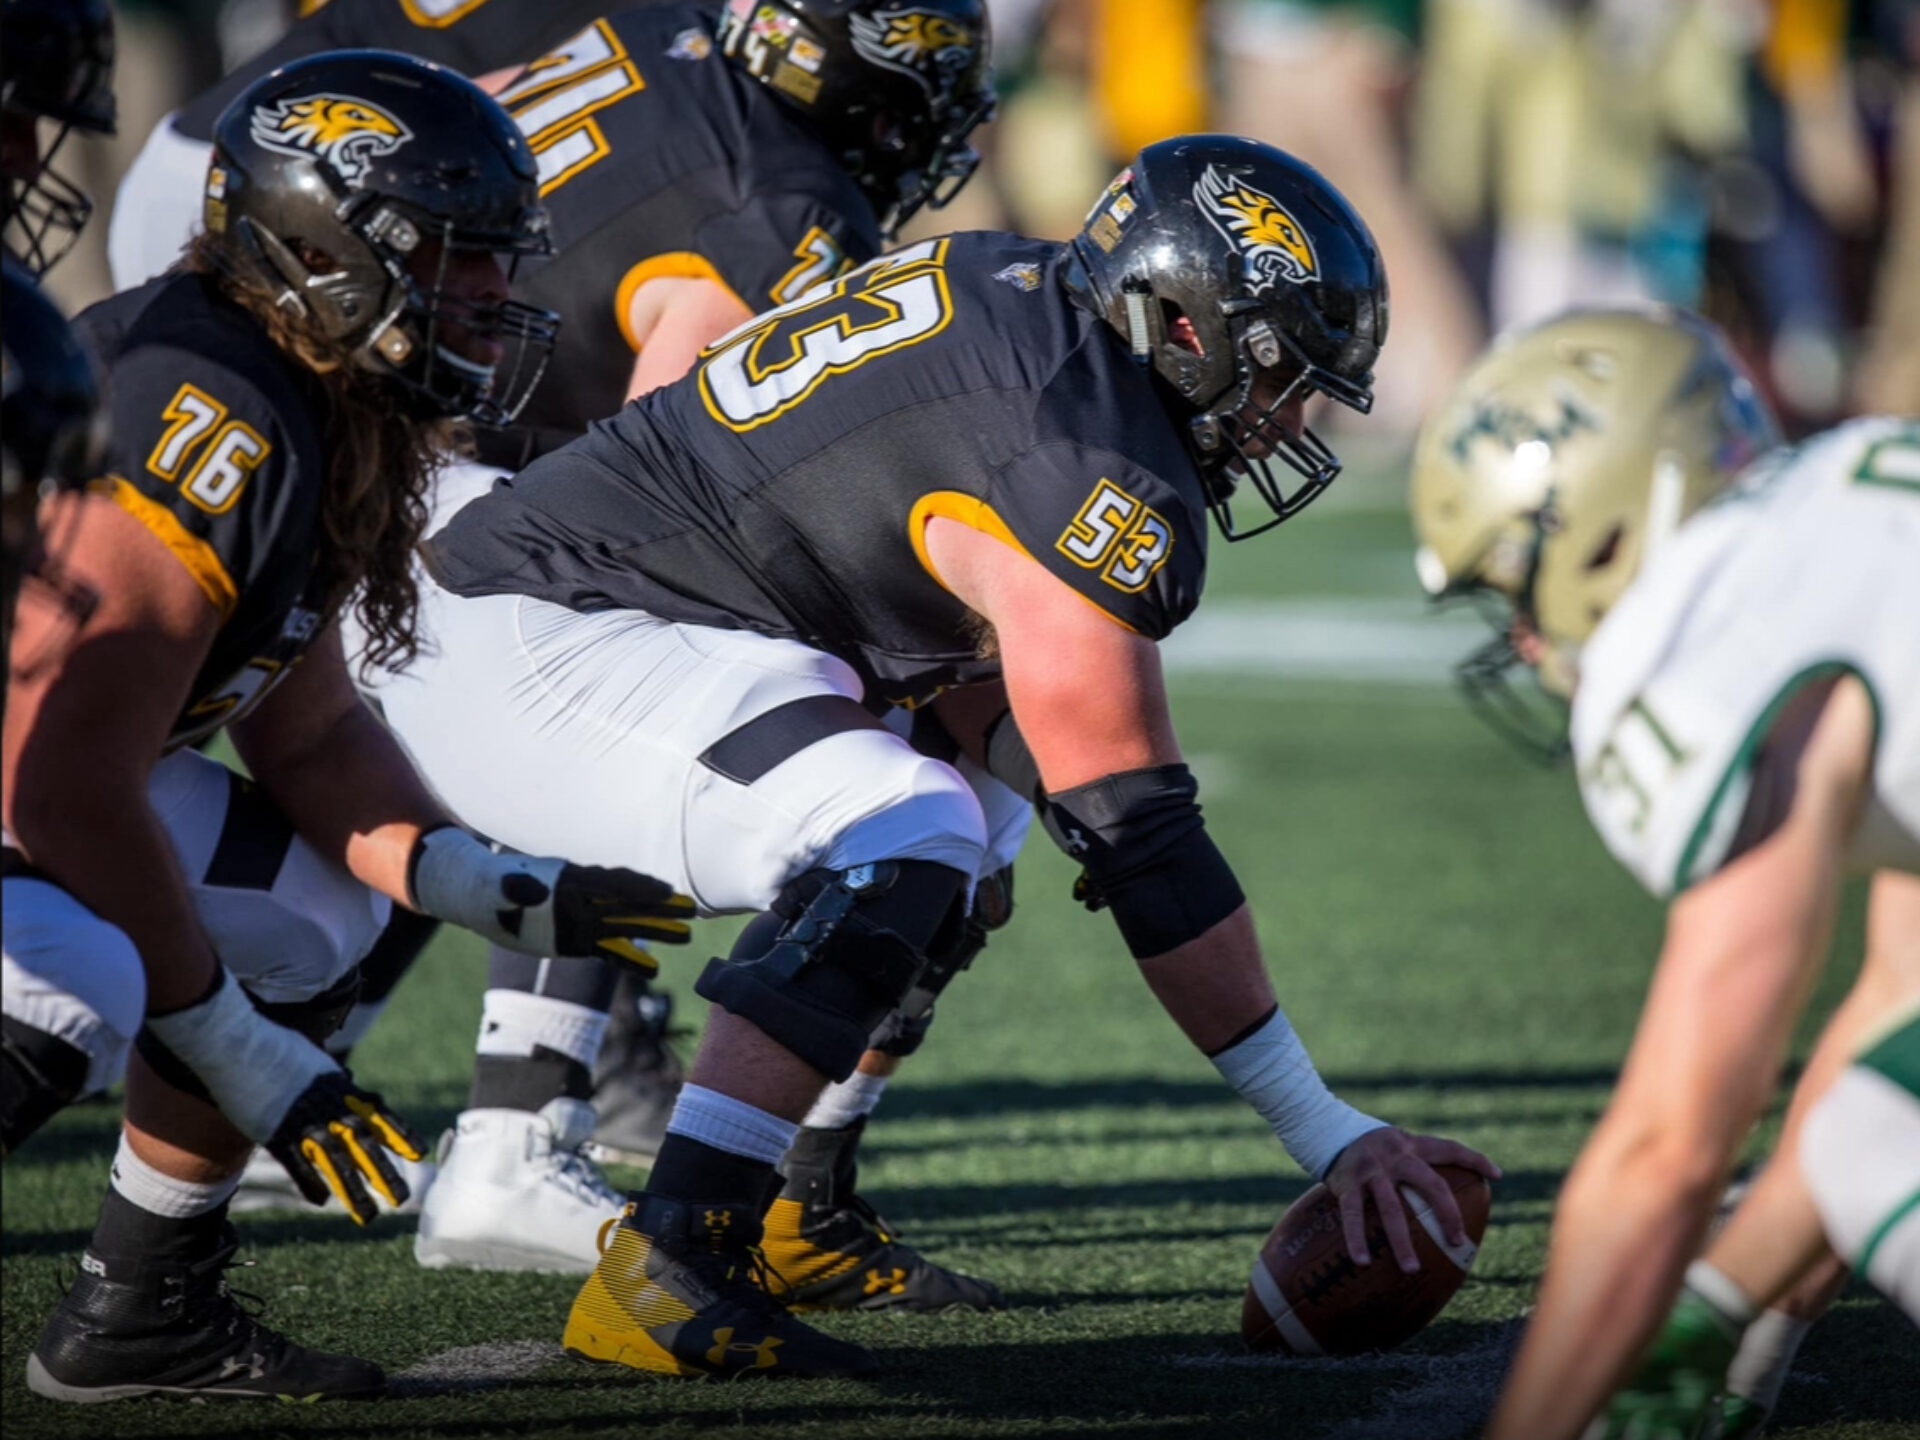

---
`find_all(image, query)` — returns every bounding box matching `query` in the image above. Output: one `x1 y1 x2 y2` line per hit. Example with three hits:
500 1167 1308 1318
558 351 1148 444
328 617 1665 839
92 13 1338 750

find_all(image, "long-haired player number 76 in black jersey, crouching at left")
4 52 691 1402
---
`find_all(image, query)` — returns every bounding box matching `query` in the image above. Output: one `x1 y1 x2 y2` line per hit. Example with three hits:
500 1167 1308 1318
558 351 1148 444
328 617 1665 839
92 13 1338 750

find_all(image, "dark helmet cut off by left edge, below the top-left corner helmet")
0 259 106 693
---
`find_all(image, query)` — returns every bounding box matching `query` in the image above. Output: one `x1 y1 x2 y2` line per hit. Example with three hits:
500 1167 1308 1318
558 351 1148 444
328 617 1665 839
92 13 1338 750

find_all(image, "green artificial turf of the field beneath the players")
0 487 1920 1440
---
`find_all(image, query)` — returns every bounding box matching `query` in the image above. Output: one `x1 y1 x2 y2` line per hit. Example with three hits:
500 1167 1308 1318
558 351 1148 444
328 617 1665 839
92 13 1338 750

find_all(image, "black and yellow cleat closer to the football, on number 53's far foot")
764 1119 1006 1311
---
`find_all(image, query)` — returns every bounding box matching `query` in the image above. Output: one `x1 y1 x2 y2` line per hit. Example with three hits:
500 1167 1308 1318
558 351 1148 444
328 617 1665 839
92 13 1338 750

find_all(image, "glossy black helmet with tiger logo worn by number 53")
1062 134 1386 540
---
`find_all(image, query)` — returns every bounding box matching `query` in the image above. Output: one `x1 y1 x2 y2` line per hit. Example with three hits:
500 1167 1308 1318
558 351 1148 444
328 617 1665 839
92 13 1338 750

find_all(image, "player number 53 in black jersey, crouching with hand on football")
388 136 1496 1375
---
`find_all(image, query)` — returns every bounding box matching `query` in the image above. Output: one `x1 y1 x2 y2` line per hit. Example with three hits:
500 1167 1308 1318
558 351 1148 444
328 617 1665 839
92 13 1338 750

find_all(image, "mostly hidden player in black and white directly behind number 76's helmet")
100 0 607 290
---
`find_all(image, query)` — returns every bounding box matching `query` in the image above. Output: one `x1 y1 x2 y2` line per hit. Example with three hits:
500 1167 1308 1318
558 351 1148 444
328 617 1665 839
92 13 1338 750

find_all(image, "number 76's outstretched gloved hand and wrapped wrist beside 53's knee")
409 826 693 972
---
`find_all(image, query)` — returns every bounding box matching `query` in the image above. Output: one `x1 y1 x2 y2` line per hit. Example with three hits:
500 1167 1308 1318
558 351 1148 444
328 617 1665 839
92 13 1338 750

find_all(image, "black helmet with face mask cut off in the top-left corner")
0 0 113 275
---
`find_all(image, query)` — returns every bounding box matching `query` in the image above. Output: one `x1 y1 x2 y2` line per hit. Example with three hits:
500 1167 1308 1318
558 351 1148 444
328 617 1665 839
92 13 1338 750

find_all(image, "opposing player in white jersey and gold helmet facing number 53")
1413 311 1920 1440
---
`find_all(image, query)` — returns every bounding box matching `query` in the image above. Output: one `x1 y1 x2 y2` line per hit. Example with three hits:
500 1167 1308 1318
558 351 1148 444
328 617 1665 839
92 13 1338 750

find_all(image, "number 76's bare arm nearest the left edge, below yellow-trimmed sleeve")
6 495 219 1012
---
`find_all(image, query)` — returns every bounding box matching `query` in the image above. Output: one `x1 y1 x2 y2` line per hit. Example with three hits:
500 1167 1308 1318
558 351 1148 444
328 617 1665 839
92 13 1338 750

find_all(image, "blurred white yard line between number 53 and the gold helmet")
1160 599 1488 685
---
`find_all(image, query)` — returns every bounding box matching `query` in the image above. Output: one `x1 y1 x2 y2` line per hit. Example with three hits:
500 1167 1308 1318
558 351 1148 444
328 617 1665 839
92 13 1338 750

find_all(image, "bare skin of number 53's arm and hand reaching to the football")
927 520 1500 1271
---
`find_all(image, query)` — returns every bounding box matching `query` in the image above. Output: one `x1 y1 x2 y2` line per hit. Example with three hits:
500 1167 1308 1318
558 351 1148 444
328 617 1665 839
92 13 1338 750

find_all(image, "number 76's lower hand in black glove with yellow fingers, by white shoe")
267 1066 422 1225
